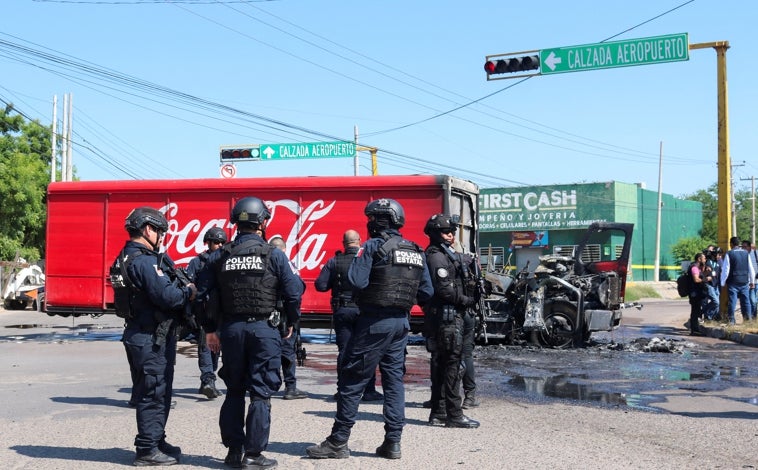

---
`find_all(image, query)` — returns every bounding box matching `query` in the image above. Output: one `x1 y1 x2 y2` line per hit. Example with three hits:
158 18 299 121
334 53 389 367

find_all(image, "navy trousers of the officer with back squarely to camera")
219 317 282 454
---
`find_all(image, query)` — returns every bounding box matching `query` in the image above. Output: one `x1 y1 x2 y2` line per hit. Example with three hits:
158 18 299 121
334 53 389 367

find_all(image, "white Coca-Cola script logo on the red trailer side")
159 199 337 270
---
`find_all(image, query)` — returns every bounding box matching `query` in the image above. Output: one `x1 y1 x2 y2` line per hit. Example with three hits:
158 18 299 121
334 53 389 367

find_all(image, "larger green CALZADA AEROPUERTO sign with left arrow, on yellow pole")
540 33 690 75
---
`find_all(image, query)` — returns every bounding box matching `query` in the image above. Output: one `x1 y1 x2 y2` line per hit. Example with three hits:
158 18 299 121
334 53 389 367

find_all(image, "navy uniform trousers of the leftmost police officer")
122 326 176 455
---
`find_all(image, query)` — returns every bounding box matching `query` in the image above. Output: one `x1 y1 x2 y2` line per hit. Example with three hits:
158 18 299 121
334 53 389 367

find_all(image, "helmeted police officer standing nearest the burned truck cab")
424 214 479 428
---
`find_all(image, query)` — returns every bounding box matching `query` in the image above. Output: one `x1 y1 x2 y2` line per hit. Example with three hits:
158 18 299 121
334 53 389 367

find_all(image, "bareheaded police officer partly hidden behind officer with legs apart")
315 230 384 401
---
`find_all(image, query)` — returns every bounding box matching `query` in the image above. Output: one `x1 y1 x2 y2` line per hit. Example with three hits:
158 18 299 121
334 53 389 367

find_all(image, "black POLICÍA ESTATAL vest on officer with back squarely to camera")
216 240 279 316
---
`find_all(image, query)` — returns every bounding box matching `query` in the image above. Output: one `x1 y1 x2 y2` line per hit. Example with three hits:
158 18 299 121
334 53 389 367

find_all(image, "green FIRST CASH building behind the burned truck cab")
479 181 705 281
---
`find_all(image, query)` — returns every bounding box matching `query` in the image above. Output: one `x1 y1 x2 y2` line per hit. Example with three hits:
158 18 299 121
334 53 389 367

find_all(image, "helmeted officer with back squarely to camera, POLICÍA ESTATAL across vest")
198 197 302 469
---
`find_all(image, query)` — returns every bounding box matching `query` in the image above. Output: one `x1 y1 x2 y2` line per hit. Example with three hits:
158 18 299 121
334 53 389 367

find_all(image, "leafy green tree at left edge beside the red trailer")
0 104 51 262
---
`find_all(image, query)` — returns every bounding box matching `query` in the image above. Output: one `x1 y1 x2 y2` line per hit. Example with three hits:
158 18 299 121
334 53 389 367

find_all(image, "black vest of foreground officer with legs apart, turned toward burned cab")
357 235 424 310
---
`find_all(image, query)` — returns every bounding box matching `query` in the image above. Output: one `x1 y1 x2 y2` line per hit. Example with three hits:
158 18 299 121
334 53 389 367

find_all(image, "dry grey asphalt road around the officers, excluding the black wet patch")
0 302 758 469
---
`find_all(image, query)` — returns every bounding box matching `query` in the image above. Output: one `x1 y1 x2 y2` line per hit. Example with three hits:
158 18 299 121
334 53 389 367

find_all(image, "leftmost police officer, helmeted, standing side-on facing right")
114 207 196 466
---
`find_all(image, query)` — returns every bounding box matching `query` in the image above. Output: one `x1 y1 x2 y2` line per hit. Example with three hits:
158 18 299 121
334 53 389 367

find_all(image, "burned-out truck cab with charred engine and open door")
477 222 634 348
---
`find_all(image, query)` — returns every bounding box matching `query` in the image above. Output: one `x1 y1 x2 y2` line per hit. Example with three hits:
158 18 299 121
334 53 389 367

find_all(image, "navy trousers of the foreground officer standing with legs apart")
330 312 410 442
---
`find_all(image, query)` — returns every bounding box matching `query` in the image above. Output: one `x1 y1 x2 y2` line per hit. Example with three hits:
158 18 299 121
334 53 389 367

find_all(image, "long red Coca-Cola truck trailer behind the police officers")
44 175 479 330
